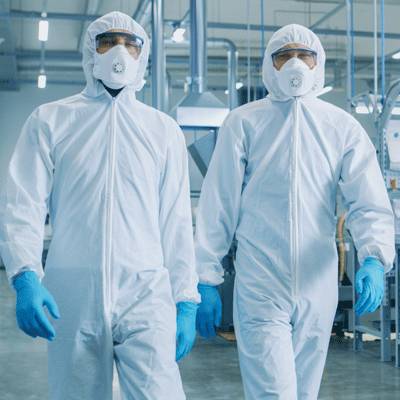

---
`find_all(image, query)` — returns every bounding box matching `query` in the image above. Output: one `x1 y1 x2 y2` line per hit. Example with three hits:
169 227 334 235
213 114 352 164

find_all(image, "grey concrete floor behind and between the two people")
0 270 400 400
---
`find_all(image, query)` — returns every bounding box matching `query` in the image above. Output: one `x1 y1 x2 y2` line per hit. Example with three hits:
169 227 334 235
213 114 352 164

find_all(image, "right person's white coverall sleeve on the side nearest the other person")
195 114 246 285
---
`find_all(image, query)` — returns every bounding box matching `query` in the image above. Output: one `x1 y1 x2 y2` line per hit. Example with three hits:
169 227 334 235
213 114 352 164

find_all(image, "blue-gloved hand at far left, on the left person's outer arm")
13 271 60 340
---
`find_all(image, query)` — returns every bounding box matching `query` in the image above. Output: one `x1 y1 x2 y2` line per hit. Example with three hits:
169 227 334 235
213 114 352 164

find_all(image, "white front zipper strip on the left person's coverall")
104 97 116 306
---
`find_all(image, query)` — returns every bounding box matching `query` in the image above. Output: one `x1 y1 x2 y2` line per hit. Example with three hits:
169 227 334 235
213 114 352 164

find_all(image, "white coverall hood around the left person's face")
82 11 150 96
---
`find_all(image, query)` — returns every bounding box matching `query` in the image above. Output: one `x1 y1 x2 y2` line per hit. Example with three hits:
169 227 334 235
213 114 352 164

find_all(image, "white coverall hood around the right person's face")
262 24 325 101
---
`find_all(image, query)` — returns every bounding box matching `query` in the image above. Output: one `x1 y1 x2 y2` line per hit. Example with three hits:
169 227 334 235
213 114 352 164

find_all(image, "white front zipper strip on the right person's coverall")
290 98 299 297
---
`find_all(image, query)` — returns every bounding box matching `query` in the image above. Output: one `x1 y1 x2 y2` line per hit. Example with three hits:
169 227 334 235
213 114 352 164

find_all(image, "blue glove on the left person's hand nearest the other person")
176 301 198 361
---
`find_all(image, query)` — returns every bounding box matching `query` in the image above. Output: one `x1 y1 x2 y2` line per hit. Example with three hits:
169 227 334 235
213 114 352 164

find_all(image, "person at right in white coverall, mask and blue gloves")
195 25 394 400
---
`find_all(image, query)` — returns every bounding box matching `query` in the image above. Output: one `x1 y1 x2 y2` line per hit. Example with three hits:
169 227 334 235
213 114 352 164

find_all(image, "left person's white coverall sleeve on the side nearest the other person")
160 123 200 303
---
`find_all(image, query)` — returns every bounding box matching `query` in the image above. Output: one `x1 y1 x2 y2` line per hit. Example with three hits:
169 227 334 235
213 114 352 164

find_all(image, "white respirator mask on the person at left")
93 45 139 89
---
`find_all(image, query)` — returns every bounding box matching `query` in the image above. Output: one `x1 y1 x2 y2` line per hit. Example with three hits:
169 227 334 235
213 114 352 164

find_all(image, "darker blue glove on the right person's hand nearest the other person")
196 283 222 338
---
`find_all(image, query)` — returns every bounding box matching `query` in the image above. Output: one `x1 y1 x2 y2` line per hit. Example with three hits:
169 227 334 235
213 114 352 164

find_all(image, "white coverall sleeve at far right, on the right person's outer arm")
339 125 395 272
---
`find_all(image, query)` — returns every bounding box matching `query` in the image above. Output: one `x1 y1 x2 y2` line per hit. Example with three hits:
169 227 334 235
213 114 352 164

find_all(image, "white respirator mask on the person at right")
275 57 315 97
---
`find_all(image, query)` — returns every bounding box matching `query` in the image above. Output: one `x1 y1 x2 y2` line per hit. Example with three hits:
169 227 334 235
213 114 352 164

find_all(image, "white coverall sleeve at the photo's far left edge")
0 110 54 283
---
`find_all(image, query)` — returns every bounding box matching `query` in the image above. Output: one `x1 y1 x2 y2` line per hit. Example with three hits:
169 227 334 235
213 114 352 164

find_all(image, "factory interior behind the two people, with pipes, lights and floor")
0 0 400 400
